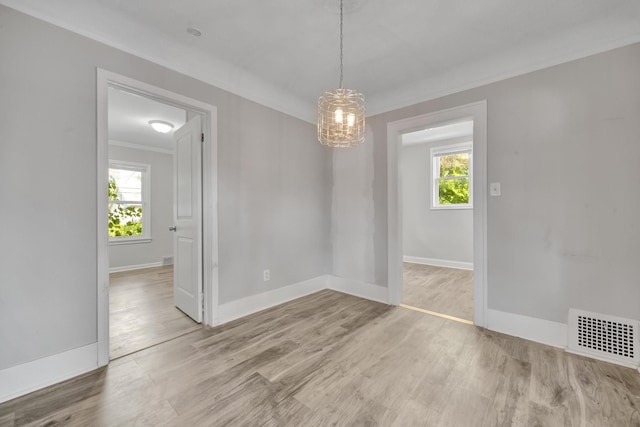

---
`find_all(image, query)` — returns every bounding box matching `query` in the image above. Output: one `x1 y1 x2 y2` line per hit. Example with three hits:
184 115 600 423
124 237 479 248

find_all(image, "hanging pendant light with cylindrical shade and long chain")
318 0 364 147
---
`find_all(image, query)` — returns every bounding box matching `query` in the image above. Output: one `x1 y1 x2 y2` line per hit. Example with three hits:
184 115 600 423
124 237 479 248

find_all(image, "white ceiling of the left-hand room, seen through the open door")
108 88 187 151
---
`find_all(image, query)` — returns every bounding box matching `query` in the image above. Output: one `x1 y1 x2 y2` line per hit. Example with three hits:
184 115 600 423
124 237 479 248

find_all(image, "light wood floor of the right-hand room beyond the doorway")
402 262 473 320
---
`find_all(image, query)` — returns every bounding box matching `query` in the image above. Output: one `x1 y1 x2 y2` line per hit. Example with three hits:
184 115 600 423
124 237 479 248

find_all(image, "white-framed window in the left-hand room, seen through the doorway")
108 161 151 244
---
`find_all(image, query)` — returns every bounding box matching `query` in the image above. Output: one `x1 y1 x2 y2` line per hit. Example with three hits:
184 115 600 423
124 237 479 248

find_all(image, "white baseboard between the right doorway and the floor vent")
486 309 567 349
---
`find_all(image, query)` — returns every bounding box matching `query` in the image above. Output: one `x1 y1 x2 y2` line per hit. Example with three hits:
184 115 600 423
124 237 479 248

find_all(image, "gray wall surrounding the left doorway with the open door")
0 6 332 369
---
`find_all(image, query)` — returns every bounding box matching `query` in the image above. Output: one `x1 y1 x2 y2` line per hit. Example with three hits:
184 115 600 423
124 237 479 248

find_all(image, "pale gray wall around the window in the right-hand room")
400 141 473 263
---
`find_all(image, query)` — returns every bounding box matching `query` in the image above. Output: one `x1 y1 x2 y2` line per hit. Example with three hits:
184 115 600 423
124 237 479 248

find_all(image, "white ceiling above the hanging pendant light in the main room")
5 0 640 122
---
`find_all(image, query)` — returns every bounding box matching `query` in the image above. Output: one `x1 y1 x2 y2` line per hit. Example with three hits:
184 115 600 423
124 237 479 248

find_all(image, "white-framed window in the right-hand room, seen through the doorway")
431 142 473 209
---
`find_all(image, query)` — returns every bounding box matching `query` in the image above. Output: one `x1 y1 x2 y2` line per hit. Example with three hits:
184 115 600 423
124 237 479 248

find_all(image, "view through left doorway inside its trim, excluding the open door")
107 86 201 360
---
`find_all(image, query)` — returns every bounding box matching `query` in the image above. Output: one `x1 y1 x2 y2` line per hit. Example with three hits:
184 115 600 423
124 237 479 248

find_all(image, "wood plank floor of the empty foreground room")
0 290 640 427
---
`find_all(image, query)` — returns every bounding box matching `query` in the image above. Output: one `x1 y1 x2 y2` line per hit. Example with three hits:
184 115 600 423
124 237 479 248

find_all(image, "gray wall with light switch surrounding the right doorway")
333 44 640 322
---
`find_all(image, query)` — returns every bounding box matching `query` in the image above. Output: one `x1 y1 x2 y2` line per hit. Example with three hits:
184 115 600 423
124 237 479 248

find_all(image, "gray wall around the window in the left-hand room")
109 145 173 268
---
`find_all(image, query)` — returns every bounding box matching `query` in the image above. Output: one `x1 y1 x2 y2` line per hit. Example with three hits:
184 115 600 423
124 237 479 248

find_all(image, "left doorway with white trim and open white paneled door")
97 69 218 366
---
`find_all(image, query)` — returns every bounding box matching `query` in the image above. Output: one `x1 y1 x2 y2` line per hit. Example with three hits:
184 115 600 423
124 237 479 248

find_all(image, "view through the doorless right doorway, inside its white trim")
400 119 473 323
